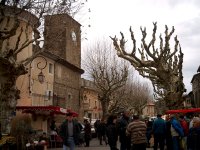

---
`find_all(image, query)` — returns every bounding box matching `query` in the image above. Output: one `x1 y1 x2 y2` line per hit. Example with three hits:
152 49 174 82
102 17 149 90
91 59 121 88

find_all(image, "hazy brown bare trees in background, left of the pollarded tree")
109 77 151 115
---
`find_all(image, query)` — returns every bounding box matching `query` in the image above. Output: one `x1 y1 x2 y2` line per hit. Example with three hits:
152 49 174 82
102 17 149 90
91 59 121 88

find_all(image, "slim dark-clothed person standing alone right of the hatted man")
84 119 92 147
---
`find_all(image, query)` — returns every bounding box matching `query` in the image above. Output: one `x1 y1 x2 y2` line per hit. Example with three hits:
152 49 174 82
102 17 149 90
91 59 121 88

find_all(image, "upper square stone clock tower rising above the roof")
44 14 81 67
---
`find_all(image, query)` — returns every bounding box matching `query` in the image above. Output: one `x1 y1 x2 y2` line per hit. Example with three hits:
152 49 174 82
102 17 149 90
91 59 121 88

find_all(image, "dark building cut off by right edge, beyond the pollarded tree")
191 66 200 107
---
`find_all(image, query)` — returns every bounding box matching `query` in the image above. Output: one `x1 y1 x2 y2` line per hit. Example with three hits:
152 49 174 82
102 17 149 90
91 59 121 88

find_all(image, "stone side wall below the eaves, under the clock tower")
54 64 80 111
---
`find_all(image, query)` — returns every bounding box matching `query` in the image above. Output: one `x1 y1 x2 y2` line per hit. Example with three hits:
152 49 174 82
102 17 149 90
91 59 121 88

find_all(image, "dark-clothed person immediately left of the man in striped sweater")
118 110 131 150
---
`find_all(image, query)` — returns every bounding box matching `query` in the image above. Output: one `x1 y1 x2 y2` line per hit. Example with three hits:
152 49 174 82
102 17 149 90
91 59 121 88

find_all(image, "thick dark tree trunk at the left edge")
0 57 26 134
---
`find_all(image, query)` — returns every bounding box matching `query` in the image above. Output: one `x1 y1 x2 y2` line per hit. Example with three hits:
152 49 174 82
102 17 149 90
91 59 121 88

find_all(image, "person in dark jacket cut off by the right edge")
187 117 200 150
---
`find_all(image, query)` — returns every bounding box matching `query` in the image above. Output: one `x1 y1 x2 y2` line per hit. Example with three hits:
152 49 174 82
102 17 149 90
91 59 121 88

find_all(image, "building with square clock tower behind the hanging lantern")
17 14 84 133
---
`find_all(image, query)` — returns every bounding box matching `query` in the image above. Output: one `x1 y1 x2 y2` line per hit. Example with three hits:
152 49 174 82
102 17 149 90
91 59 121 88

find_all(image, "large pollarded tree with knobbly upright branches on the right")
110 22 185 109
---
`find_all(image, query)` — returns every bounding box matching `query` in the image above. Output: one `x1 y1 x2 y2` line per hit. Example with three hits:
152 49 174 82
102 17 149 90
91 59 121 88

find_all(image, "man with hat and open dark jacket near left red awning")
59 112 80 150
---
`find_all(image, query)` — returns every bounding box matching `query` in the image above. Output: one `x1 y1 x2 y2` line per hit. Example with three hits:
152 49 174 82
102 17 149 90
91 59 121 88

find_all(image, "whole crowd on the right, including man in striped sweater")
97 111 200 150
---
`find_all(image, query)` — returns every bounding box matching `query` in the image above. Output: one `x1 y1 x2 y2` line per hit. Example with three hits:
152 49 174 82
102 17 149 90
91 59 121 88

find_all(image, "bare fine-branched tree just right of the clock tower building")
84 41 128 117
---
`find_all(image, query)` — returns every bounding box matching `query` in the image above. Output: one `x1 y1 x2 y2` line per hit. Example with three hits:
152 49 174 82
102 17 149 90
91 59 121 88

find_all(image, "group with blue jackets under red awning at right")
149 114 200 150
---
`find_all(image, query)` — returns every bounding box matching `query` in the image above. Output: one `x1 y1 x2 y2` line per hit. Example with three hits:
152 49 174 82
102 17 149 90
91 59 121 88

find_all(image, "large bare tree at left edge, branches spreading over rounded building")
0 0 86 133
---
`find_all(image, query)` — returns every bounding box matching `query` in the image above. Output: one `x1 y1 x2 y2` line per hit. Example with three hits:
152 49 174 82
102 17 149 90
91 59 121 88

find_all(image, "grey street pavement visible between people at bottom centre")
48 138 153 150
